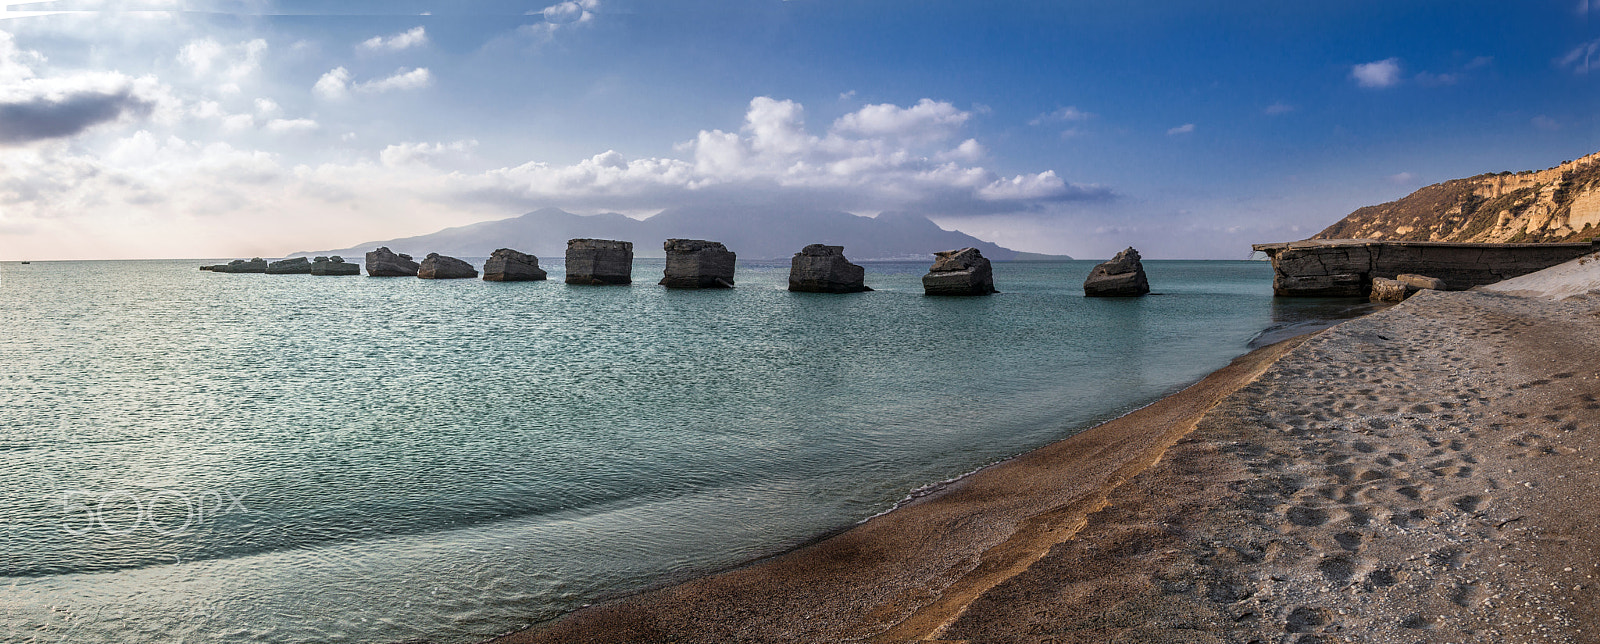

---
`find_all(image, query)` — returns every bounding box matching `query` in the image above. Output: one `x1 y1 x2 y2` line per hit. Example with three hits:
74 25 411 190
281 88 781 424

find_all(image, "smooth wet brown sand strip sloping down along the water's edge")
494 331 1304 644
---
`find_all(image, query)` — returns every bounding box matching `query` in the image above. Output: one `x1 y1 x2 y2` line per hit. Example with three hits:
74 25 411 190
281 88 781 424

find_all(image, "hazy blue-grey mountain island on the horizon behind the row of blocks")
291 208 1070 261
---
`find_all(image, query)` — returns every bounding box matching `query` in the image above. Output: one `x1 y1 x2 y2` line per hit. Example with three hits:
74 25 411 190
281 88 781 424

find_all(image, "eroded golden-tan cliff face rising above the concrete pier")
1312 152 1600 242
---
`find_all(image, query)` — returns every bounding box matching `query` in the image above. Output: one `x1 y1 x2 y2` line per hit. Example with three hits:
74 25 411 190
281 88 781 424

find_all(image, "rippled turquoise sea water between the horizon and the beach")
0 260 1344 642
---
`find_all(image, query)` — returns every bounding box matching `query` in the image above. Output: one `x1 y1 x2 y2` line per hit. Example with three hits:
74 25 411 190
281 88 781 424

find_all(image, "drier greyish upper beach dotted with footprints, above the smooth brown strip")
944 292 1600 644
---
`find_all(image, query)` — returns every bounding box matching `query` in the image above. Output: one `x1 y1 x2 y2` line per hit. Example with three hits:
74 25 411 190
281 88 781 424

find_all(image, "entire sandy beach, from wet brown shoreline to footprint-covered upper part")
496 286 1600 642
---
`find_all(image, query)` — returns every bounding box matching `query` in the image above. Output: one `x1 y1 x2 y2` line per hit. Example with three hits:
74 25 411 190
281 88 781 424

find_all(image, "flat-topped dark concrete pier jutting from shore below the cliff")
1251 239 1600 298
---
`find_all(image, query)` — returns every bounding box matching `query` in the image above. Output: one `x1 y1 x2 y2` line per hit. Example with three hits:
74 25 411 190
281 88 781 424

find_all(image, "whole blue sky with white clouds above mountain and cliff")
0 0 1600 260
